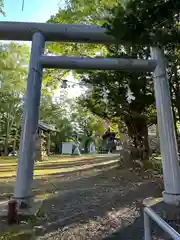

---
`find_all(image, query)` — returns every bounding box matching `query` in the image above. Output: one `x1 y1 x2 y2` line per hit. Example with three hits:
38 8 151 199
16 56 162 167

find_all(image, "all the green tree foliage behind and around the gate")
0 0 180 161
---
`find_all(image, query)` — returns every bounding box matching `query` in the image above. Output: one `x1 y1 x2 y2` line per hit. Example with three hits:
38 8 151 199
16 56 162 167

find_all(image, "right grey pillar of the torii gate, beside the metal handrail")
151 47 180 204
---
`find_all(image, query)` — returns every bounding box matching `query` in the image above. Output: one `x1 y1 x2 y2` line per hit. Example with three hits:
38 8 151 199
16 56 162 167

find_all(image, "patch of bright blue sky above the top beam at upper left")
0 0 64 22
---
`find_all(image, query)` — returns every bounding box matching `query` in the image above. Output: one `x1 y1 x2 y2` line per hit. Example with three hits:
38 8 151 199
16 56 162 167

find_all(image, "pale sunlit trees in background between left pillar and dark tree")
40 93 105 152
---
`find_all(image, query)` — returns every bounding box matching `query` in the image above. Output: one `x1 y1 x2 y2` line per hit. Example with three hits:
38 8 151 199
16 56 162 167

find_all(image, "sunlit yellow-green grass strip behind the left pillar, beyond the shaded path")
0 155 118 200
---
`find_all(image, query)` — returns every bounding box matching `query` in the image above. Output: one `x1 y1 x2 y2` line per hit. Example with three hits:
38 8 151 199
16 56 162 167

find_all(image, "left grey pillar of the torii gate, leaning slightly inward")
14 32 45 203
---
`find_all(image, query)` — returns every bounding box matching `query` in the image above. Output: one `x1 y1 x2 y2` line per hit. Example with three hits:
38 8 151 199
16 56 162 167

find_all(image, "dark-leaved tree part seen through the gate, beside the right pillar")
81 45 156 159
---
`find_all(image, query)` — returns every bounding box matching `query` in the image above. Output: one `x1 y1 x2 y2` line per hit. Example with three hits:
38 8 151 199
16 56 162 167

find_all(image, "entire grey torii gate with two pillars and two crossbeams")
0 22 180 204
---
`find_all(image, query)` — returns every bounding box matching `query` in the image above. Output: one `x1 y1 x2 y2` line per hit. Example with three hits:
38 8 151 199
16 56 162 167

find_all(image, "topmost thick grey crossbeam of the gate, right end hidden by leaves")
0 22 116 44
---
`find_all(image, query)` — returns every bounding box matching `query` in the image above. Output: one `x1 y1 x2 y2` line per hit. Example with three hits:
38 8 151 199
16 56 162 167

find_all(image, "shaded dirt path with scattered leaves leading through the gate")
36 163 161 240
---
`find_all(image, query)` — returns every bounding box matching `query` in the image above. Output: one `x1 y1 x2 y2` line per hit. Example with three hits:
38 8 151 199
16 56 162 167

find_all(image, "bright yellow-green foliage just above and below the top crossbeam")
48 0 119 57
